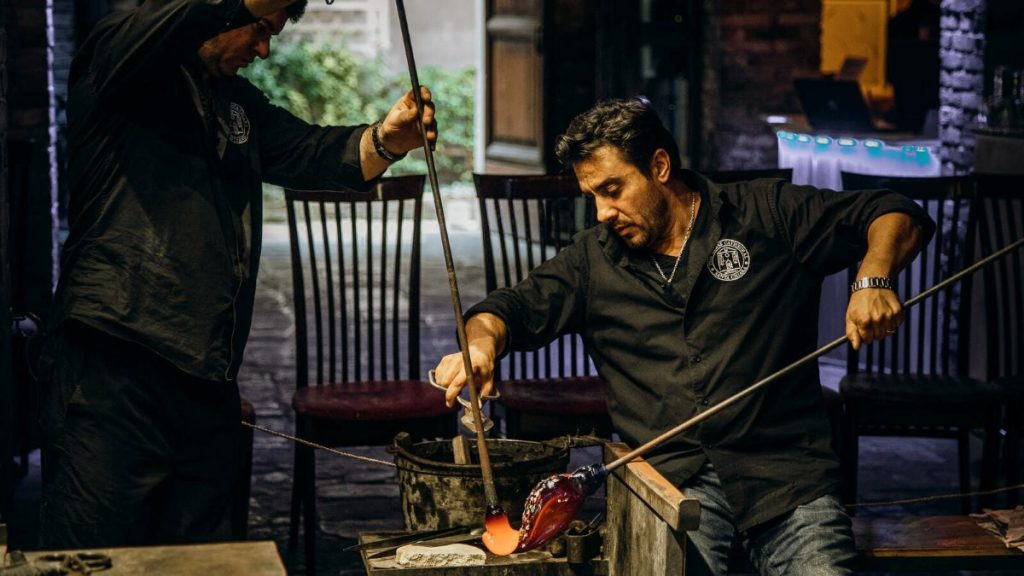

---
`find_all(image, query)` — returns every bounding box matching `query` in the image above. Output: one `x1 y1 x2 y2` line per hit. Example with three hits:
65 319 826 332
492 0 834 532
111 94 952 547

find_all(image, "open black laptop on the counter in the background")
793 78 879 132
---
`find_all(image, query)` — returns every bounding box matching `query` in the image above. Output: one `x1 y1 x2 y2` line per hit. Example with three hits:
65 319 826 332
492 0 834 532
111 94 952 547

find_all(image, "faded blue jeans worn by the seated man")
680 460 856 576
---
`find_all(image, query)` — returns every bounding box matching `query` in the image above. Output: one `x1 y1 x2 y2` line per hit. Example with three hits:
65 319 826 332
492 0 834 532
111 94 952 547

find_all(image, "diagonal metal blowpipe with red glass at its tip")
496 238 1024 553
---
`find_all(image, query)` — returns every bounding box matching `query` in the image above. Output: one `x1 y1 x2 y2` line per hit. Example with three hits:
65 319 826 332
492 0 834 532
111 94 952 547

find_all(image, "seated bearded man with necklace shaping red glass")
436 99 934 575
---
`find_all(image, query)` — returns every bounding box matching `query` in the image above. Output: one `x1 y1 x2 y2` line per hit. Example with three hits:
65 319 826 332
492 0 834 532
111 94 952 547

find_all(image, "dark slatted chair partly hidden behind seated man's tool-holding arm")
473 174 611 440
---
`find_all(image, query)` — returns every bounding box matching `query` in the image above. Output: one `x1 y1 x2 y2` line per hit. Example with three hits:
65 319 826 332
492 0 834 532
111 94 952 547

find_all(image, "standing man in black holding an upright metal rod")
42 0 437 548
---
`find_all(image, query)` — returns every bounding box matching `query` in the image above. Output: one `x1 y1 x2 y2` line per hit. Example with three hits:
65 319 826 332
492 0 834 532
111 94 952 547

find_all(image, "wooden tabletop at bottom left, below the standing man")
26 540 288 576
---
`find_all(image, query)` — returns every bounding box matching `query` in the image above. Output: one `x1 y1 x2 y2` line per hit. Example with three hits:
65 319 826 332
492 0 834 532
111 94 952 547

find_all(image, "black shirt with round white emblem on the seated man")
468 172 933 530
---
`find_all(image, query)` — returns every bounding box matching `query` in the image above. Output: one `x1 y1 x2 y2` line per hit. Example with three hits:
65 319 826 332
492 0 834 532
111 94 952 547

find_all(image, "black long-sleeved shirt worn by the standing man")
51 0 369 380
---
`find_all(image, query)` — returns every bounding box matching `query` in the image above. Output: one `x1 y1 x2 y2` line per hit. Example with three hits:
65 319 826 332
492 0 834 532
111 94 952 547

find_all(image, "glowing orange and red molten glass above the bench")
483 464 608 556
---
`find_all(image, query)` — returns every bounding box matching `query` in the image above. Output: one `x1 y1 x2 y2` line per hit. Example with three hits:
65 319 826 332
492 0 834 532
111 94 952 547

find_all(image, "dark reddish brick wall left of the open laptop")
702 0 821 170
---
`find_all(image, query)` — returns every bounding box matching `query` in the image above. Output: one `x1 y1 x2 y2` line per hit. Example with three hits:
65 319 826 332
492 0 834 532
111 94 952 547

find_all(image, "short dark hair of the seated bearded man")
555 96 682 176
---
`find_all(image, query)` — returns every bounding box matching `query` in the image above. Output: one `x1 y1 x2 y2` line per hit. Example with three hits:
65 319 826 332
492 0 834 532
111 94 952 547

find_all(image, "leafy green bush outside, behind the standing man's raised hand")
243 41 475 182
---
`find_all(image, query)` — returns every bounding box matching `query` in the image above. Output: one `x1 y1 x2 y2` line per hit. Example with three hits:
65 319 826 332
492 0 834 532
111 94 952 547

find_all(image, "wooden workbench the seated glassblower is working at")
365 443 1024 576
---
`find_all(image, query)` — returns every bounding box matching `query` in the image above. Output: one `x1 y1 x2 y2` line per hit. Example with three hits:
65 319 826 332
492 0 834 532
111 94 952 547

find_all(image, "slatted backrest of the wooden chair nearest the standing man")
286 176 425 386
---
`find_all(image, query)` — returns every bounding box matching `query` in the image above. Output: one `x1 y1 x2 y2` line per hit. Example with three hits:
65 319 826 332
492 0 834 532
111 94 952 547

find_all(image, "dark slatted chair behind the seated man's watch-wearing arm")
840 172 999 512
